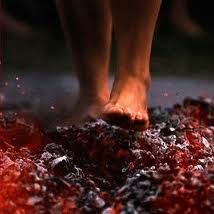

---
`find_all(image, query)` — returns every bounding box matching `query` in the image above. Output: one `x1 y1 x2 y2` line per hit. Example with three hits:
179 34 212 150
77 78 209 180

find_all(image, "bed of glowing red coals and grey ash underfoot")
0 98 214 214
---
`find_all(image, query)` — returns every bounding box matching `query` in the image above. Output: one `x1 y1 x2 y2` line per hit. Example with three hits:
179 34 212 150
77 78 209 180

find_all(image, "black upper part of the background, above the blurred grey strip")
2 0 214 78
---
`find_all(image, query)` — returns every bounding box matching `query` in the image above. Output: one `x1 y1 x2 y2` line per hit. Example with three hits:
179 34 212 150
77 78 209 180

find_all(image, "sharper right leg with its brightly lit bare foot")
105 0 161 126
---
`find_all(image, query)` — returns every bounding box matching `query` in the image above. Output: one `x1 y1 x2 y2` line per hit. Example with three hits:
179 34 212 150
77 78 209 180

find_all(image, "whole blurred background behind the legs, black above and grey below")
1 0 214 123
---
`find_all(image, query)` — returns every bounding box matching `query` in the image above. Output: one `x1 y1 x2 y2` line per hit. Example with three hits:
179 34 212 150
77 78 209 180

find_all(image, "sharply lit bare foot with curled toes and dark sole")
103 78 149 129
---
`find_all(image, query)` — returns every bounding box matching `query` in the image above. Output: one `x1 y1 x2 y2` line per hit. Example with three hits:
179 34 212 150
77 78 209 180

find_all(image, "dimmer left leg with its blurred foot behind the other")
56 0 112 123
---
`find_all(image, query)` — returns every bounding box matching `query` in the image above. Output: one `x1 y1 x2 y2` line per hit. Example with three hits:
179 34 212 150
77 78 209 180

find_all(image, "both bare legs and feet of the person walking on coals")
56 0 161 128
